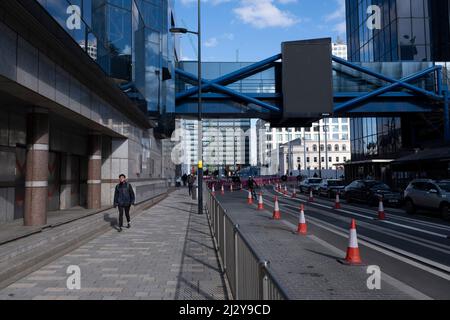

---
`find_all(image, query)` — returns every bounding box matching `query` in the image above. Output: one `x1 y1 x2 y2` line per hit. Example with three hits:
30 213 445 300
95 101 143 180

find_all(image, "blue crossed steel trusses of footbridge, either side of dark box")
176 55 450 121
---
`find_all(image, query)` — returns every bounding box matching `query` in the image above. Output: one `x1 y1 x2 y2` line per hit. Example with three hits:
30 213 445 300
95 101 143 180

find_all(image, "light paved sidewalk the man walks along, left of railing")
0 189 228 300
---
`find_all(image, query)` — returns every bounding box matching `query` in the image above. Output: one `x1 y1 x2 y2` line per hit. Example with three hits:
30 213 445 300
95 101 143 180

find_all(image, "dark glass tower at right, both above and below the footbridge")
346 0 450 187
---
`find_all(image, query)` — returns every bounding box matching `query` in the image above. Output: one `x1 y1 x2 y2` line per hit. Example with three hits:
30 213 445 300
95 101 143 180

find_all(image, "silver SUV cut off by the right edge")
404 179 450 220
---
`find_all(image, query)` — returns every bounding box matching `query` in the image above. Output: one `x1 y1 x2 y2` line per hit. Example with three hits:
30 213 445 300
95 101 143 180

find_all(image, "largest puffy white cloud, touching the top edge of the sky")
233 0 299 29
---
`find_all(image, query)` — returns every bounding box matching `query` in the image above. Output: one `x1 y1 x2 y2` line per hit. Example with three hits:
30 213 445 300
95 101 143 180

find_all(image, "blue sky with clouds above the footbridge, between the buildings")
175 0 345 61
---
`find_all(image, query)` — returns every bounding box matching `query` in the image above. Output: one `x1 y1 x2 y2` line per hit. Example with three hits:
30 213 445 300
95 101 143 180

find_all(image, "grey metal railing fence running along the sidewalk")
204 186 289 300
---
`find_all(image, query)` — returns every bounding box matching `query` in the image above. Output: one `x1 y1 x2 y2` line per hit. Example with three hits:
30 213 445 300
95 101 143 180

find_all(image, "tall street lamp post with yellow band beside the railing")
170 0 203 214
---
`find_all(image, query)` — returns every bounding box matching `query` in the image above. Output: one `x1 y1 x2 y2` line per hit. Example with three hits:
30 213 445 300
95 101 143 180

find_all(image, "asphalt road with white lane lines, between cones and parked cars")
229 186 450 299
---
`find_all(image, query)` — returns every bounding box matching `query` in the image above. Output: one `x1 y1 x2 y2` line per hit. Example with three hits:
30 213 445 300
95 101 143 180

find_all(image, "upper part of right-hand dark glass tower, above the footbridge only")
346 0 450 62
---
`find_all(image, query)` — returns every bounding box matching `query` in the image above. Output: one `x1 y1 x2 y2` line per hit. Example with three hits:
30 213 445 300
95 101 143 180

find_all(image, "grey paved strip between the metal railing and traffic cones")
217 191 426 300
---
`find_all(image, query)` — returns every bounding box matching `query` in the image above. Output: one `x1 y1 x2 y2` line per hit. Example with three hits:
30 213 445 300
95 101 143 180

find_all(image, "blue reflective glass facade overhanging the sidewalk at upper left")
37 0 175 116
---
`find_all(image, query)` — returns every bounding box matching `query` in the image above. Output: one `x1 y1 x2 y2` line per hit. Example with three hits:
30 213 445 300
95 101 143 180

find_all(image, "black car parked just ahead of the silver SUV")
344 180 402 206
